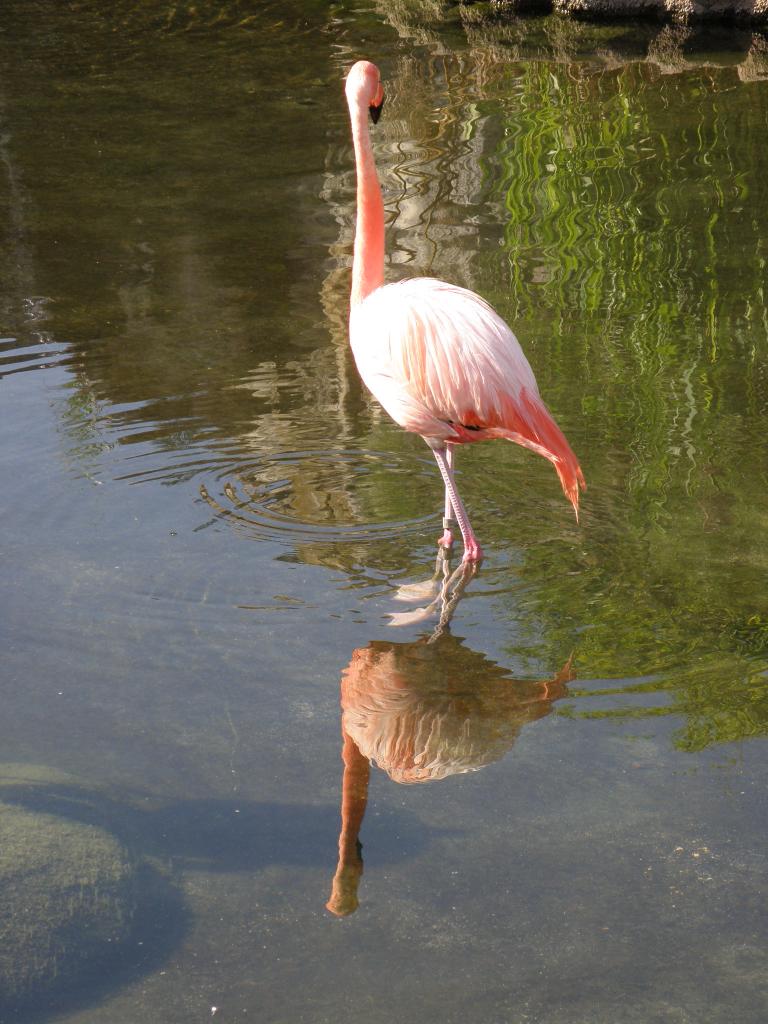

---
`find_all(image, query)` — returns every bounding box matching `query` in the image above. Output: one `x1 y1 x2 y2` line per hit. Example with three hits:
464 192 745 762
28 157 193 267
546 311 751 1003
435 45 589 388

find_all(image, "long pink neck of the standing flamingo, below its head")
349 102 384 306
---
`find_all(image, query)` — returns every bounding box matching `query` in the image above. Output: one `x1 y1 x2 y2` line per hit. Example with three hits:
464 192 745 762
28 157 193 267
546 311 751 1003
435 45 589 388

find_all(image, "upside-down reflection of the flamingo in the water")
326 559 572 916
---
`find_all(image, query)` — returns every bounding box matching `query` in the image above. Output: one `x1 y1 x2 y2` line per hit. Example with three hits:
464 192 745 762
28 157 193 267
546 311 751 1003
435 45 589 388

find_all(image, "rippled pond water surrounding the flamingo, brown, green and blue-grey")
0 0 768 1024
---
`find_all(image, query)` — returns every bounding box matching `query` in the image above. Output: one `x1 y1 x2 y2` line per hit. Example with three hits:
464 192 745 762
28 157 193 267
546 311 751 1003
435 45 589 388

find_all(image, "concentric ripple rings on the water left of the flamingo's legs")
200 449 435 542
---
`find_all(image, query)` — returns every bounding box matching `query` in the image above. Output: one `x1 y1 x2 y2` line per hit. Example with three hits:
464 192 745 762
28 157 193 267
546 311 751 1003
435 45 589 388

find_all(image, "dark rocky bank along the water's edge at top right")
377 0 768 82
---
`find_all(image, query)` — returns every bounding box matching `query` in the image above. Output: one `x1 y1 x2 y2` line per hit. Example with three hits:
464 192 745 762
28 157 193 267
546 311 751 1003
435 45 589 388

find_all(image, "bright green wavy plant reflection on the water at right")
466 49 768 750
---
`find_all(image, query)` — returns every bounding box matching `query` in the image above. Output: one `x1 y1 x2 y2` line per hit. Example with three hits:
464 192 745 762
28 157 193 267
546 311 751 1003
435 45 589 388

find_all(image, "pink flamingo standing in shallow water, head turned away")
346 60 586 562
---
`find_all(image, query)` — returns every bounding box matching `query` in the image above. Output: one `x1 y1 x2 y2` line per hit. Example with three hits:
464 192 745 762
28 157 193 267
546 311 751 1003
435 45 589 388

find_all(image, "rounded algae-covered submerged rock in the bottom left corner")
0 803 135 1010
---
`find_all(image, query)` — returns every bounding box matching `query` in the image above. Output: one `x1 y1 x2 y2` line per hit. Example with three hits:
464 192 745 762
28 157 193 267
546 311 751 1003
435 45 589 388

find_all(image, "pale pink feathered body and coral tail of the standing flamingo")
349 278 584 514
